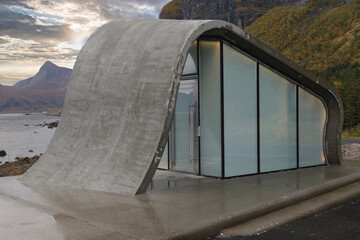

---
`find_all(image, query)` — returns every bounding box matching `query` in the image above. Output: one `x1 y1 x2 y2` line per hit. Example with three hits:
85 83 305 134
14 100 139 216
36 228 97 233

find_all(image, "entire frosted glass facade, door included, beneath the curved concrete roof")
159 39 327 178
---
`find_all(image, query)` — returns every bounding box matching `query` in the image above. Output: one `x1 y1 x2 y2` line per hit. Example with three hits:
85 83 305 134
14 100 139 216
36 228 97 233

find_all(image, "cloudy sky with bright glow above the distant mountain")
0 0 169 85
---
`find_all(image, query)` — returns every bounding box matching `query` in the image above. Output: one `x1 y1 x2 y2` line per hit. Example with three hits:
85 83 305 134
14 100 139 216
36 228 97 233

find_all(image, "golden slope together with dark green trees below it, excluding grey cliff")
245 0 360 133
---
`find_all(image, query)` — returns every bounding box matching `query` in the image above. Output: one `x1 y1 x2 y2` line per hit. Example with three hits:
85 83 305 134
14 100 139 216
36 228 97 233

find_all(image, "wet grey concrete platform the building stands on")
0 166 360 240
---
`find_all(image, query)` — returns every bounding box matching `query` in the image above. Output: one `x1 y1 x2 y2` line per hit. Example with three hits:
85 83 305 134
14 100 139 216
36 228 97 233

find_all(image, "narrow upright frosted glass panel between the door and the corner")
200 41 221 177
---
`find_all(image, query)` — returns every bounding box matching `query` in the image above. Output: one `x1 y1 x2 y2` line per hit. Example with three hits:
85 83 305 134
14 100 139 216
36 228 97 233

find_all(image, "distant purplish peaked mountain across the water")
0 62 71 113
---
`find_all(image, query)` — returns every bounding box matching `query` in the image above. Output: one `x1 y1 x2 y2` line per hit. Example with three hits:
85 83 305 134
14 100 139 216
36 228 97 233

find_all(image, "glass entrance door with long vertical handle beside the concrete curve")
172 79 199 173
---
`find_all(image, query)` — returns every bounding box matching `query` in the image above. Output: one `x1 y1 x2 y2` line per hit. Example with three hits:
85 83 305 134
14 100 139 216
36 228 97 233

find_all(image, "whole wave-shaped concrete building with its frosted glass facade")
22 19 343 194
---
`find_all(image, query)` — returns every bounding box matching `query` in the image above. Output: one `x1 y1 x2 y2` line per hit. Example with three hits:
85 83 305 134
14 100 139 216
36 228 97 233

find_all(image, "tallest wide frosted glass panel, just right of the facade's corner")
223 44 257 177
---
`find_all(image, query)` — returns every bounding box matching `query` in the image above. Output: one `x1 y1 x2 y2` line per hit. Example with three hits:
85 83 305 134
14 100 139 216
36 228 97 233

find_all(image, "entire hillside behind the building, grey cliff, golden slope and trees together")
160 0 360 130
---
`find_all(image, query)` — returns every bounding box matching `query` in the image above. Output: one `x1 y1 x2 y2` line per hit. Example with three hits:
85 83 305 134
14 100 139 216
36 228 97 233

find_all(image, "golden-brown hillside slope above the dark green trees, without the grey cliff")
246 1 360 73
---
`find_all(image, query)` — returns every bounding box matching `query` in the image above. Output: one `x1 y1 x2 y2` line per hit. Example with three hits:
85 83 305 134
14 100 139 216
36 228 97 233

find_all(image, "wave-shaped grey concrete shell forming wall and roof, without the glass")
22 19 342 194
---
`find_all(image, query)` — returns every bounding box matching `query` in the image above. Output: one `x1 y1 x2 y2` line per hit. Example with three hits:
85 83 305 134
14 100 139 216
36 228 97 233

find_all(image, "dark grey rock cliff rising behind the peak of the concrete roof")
159 0 308 29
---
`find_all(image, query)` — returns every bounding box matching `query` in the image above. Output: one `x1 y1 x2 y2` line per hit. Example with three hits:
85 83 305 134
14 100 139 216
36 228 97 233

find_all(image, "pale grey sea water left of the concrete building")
0 113 60 163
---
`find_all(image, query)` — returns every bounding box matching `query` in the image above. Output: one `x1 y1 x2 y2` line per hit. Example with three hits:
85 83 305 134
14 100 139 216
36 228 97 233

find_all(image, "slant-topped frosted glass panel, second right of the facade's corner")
259 66 296 172
